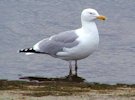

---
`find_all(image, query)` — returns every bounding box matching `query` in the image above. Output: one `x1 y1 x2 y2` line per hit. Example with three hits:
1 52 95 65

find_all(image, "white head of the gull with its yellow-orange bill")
81 8 106 22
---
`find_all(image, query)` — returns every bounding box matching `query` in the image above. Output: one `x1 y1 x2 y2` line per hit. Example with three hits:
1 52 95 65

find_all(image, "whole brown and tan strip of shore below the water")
0 80 135 100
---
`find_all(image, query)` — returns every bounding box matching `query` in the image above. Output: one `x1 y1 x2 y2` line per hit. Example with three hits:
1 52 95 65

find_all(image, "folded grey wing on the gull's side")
34 31 79 56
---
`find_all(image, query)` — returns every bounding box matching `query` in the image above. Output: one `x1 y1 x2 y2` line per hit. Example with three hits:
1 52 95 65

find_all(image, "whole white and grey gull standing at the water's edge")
19 8 106 76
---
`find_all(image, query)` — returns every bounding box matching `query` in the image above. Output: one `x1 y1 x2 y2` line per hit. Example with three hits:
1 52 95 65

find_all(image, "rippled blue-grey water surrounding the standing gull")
0 0 135 83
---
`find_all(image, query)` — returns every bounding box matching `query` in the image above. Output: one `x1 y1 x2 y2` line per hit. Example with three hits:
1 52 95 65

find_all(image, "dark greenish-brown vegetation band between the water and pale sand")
0 80 135 97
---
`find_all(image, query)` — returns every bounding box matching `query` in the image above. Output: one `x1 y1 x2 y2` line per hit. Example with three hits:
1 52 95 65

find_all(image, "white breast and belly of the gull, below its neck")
58 29 99 60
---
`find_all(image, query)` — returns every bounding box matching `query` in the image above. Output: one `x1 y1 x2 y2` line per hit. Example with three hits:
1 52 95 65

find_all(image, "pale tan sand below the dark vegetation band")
0 88 135 100
